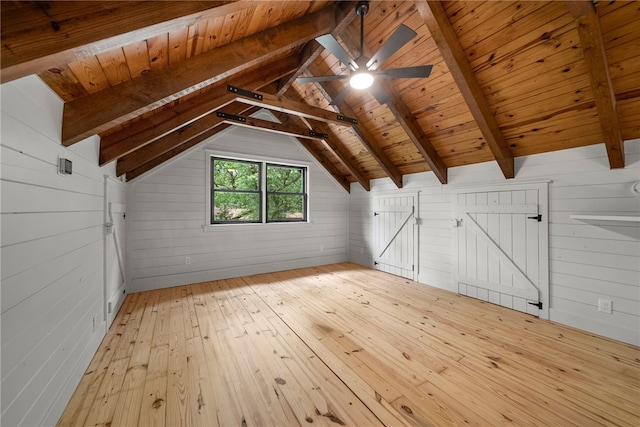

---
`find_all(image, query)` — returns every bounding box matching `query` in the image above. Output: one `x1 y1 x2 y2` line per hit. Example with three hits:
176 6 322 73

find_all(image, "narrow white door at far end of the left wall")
104 176 126 330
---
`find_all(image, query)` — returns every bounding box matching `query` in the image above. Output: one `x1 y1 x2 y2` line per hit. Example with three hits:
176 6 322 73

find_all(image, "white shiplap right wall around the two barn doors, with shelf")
349 140 640 345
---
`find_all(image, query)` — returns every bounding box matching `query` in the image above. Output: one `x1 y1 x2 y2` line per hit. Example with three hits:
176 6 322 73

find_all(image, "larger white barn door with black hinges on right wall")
455 183 549 319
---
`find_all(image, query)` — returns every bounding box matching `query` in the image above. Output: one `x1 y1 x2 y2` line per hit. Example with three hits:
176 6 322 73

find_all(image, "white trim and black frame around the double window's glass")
203 152 312 231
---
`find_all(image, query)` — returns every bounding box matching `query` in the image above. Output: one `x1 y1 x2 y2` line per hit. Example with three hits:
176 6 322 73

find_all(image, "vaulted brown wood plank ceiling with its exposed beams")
1 0 640 191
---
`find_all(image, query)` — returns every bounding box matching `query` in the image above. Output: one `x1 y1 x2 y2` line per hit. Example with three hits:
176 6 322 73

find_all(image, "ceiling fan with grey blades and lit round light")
297 1 433 105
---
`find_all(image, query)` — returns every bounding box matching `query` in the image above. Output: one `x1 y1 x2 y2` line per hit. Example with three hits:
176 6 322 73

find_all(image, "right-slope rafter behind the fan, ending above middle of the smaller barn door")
308 61 402 188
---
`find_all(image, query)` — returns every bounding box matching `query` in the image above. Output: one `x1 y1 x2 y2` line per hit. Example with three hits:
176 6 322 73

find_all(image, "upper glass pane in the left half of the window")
213 159 260 191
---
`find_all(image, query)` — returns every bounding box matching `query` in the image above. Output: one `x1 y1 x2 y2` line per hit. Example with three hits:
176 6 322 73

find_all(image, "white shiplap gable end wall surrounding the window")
127 122 348 291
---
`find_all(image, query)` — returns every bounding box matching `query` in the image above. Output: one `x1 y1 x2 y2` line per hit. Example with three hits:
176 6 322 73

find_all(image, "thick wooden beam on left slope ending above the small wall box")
62 6 335 146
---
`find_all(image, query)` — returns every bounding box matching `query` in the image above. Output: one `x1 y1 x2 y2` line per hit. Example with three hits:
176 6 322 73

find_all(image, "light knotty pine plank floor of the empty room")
59 263 640 427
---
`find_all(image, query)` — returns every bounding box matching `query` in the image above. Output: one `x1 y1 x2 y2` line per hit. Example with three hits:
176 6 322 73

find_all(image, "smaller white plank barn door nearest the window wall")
373 193 418 280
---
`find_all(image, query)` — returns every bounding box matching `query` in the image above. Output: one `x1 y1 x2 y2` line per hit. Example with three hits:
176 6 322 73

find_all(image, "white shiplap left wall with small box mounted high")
0 76 124 426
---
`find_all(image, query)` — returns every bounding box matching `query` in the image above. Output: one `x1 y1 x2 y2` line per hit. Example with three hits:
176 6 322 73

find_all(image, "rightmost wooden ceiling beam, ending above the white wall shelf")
565 1 625 169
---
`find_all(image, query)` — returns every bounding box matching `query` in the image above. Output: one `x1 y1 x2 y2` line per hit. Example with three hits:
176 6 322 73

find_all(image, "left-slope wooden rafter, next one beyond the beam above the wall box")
99 55 298 165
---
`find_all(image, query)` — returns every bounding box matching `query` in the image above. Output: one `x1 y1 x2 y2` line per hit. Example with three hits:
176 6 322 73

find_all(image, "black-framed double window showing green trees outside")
210 157 307 224
